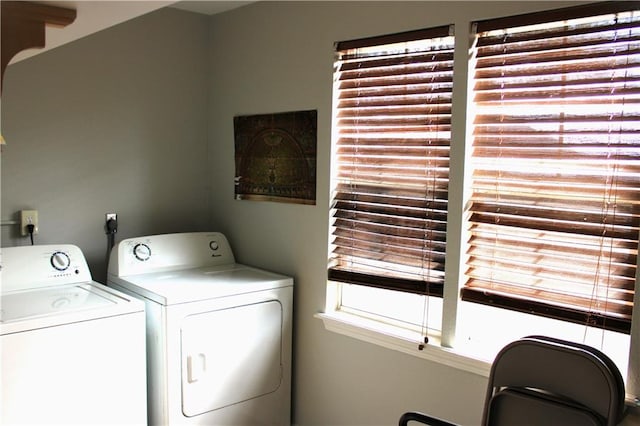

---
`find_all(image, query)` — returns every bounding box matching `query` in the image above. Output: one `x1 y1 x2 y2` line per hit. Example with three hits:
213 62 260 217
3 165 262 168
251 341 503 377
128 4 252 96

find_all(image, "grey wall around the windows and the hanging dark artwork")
209 1 592 426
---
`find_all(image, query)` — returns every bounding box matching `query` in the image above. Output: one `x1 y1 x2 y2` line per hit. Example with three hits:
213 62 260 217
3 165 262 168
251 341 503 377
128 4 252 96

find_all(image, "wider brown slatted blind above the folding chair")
462 2 640 333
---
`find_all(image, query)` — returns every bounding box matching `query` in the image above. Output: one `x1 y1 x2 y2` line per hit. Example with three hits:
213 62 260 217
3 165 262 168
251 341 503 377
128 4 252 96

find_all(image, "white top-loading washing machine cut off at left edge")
0 244 147 425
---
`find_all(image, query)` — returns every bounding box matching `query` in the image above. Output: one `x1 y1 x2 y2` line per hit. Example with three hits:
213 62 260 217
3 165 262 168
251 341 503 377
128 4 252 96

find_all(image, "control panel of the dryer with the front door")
109 232 235 276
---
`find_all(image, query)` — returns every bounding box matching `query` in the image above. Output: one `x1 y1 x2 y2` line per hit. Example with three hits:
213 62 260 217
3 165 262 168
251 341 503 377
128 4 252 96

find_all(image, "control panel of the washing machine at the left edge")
0 244 91 293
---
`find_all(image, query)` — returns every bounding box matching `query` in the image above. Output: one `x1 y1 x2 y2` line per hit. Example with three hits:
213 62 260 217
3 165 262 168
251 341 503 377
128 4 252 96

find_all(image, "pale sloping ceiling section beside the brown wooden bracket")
10 0 253 63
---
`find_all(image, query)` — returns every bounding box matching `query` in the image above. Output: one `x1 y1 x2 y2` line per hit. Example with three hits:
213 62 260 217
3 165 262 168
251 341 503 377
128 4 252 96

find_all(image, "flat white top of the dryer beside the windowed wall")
109 263 293 305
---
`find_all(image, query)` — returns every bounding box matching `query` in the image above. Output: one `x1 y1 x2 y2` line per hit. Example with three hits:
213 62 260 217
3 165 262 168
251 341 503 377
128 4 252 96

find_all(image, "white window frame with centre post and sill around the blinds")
324 2 640 398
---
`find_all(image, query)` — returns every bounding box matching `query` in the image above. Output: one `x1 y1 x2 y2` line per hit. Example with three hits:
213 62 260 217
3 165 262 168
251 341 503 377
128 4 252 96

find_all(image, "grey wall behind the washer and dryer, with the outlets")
1 7 211 281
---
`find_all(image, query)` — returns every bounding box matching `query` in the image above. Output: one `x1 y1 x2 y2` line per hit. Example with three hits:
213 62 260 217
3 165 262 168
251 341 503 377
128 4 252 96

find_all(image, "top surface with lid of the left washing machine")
0 282 144 334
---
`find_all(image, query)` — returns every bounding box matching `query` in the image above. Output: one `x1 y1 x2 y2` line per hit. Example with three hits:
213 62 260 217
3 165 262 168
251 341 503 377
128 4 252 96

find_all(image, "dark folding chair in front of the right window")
399 335 625 426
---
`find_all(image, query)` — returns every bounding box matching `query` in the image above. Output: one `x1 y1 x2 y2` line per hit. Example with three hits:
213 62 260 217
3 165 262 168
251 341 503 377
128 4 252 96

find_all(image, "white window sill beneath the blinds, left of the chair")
315 311 491 377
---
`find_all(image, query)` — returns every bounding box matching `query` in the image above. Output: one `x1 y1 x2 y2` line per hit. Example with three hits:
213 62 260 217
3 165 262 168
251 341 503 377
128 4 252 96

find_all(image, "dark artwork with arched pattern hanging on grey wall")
233 110 318 204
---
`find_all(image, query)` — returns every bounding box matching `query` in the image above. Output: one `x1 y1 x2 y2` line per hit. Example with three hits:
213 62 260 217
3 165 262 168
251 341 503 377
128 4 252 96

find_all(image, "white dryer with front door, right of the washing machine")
108 232 293 426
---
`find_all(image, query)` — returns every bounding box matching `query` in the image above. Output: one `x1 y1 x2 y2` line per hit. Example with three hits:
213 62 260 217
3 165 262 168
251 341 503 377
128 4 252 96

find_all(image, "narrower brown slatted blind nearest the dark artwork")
329 26 454 295
